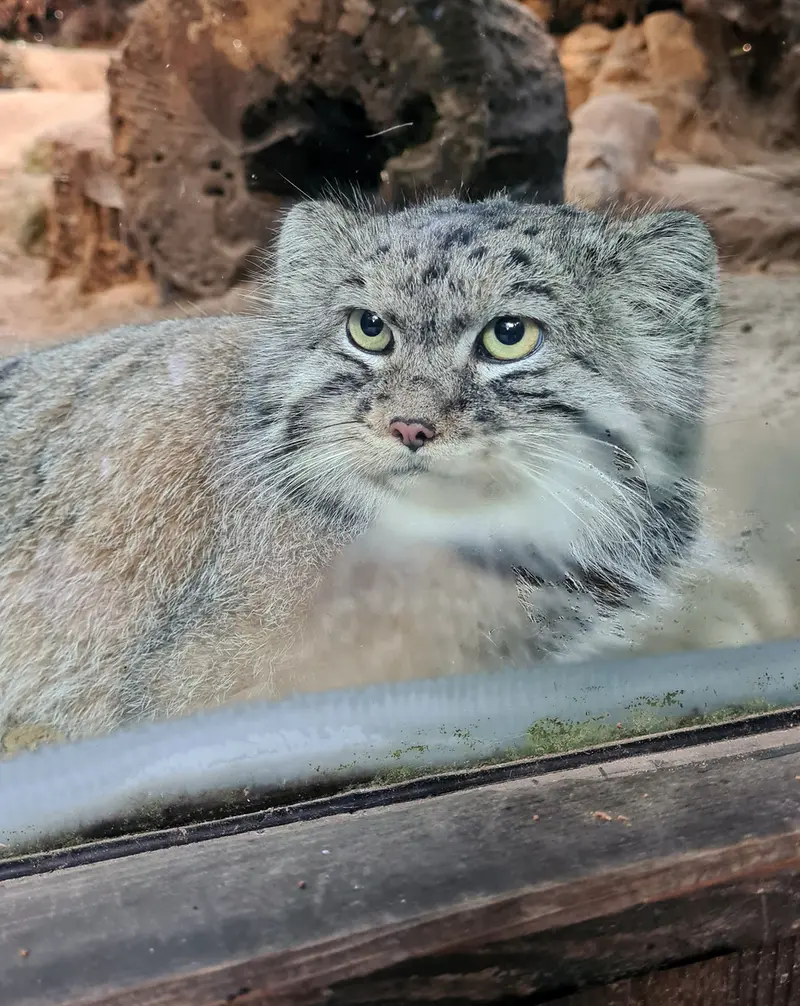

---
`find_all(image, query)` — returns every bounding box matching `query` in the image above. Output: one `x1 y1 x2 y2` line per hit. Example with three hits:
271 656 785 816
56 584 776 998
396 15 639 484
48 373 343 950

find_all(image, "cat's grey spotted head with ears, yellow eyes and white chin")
245 199 715 567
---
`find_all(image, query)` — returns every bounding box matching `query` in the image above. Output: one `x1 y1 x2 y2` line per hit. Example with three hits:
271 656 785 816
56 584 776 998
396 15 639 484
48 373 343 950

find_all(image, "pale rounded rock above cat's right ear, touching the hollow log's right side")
565 94 659 209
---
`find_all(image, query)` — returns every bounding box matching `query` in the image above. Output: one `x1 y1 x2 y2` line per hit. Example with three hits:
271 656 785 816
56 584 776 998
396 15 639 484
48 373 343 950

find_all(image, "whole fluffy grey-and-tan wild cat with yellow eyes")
0 199 788 736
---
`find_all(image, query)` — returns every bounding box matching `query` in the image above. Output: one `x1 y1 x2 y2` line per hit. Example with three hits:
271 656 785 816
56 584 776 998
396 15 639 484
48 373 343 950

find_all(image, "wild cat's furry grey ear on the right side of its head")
603 209 718 345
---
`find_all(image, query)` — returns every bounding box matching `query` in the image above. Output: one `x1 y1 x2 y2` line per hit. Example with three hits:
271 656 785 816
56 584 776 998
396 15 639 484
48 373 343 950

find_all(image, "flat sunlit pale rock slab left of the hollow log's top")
0 41 111 92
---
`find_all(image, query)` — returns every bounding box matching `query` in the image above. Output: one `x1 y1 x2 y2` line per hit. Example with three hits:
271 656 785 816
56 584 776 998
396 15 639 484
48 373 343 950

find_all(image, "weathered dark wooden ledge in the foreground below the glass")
0 728 800 1006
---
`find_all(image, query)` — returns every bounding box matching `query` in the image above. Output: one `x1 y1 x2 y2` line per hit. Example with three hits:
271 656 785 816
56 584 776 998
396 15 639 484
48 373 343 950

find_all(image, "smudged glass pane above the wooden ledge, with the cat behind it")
0 0 800 856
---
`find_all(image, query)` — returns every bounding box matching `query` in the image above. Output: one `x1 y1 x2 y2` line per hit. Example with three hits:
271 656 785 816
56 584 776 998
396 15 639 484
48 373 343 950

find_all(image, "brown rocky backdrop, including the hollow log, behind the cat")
0 0 800 352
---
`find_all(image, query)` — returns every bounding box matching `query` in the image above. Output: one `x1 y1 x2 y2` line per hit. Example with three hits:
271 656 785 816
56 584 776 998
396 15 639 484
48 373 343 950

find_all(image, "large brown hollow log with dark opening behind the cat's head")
109 0 569 295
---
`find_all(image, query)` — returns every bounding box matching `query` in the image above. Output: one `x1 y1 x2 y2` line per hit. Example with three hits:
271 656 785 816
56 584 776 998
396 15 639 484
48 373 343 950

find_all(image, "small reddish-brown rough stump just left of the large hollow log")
42 114 148 294
